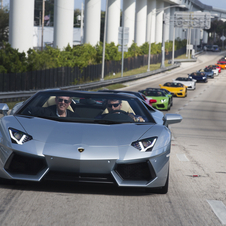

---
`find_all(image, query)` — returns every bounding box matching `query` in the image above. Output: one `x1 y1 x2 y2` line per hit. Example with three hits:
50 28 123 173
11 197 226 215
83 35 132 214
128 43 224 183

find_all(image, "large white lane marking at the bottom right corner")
207 200 226 225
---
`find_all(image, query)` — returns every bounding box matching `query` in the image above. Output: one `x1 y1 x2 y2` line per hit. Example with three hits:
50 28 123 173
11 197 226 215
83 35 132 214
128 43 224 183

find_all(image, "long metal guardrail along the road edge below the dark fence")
0 62 181 102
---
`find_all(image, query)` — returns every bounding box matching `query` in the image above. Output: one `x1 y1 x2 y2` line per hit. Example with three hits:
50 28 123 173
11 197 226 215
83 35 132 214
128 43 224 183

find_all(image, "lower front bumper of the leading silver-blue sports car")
1 146 170 187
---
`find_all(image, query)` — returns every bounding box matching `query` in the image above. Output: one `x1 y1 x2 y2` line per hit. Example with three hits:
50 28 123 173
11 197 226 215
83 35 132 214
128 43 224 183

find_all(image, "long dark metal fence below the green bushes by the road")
0 48 186 92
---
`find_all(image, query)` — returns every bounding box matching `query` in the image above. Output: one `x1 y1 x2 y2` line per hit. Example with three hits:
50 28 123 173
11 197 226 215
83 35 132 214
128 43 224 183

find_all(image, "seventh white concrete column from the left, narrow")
146 0 156 43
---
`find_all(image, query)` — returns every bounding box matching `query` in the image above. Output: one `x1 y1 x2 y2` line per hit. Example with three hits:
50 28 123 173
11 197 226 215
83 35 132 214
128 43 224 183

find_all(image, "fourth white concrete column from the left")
106 0 120 45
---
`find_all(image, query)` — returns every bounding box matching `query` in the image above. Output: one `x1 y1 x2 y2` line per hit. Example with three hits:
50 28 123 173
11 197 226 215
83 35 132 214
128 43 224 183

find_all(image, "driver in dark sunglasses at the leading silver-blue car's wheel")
102 100 145 122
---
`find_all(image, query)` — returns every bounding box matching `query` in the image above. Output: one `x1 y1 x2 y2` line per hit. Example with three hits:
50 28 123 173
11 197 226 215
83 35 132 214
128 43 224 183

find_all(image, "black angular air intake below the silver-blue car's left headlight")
4 152 47 175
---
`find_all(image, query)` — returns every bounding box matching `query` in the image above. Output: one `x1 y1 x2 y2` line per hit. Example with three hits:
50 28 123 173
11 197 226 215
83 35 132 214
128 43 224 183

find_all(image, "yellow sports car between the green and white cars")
159 82 188 97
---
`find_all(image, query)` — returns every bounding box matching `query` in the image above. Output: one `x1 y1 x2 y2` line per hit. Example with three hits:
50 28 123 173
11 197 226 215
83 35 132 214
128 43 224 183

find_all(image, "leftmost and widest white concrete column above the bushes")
9 0 35 53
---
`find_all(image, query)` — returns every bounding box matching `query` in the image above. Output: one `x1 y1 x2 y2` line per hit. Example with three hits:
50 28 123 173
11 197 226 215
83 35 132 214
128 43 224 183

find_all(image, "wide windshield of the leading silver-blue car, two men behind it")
14 91 155 124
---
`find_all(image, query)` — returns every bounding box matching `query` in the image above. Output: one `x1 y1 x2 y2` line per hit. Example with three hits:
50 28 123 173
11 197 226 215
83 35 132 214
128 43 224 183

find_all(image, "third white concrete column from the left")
83 0 101 46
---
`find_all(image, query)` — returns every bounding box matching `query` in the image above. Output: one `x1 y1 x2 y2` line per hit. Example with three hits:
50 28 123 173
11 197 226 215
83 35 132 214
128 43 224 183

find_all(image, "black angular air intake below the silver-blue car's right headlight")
115 162 156 181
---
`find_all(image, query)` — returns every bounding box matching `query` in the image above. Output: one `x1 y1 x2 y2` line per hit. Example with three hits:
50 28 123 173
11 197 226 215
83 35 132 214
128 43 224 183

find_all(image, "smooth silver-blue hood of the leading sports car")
5 116 166 158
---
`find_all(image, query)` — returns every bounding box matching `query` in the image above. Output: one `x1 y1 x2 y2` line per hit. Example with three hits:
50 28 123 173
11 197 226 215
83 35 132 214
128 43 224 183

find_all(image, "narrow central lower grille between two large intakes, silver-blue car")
43 170 115 184
